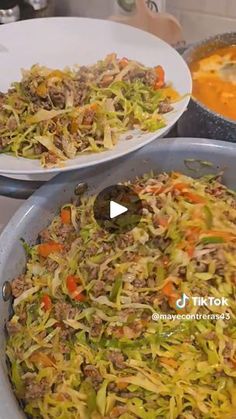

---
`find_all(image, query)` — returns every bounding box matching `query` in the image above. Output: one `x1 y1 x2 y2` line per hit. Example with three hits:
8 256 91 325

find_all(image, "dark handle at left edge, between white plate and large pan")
0 175 45 199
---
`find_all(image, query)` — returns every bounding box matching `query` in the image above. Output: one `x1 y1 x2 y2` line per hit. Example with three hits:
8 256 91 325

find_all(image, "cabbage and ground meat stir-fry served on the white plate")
0 54 180 167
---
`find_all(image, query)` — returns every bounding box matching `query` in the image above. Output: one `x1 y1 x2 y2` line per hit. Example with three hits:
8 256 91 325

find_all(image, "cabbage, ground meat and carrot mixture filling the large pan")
6 172 236 419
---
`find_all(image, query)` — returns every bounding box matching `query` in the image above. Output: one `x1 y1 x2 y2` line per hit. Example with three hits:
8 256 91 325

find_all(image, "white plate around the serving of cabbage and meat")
0 18 192 175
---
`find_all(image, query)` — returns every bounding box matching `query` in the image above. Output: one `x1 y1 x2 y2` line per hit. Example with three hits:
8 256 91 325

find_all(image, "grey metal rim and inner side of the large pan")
0 138 236 419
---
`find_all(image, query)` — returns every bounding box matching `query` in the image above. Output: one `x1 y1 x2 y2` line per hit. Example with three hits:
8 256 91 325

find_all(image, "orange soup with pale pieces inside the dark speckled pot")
190 45 236 121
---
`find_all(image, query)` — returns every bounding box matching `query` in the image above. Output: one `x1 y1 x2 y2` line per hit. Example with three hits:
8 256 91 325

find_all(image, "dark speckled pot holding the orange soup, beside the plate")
178 32 236 142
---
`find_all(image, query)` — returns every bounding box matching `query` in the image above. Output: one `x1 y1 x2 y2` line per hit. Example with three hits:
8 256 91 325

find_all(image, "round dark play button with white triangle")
93 185 142 234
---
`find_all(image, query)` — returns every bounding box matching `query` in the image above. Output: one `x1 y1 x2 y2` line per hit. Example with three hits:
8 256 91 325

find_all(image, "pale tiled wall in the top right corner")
166 0 236 42
